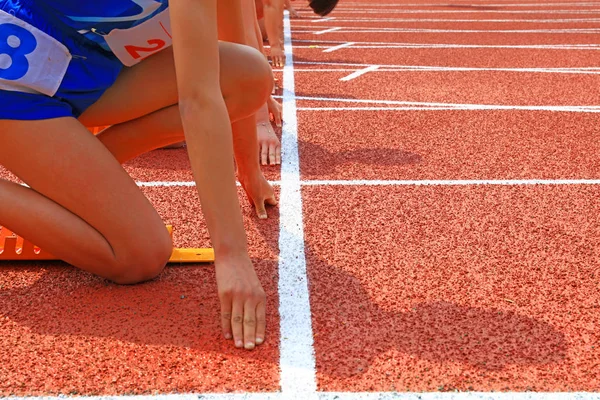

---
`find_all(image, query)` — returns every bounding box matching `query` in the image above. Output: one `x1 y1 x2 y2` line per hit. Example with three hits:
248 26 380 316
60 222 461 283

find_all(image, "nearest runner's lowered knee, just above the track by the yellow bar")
109 230 173 285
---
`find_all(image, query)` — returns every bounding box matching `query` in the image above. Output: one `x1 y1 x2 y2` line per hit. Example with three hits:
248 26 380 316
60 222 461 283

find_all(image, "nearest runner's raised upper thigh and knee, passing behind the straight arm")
79 42 268 126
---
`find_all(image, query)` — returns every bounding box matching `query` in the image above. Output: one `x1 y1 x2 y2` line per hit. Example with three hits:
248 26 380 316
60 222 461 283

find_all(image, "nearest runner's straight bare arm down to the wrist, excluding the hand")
170 0 247 258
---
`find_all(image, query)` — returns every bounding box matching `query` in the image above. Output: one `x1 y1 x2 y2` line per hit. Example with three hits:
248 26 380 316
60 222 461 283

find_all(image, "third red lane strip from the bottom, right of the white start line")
296 71 600 107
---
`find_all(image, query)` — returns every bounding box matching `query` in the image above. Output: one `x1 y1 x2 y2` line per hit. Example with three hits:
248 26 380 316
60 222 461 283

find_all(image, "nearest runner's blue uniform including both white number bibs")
0 0 171 120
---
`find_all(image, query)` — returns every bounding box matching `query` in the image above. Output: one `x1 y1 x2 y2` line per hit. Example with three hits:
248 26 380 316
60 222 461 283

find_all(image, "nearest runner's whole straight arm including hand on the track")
170 0 265 349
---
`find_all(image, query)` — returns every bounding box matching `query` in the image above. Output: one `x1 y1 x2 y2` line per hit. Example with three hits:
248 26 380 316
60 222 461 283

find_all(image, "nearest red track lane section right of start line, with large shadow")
304 187 600 392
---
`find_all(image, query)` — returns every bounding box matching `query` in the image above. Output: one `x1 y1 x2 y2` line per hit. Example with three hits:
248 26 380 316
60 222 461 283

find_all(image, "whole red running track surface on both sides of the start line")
0 0 600 396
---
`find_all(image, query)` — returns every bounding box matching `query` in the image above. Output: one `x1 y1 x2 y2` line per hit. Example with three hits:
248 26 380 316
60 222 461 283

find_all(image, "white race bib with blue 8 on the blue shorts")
0 10 72 96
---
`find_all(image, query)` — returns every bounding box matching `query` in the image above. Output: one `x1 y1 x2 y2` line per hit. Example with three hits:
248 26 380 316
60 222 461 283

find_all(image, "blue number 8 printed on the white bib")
0 24 37 81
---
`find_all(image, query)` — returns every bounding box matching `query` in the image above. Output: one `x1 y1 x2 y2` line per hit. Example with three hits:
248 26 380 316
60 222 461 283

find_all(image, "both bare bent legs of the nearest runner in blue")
0 43 271 284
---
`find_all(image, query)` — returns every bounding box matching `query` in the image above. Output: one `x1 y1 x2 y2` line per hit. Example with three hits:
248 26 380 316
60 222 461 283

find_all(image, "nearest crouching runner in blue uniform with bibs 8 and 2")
0 0 273 349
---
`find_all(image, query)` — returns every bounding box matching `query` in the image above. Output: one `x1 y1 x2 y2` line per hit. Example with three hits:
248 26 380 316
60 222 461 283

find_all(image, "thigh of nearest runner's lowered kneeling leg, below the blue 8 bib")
0 118 168 256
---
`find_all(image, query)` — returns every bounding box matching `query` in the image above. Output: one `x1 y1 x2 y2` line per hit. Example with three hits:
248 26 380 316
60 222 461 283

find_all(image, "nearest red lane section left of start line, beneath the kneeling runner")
0 188 279 396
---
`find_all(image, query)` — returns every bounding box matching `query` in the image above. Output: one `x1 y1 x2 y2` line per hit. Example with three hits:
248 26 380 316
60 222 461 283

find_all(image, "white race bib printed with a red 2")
104 8 173 67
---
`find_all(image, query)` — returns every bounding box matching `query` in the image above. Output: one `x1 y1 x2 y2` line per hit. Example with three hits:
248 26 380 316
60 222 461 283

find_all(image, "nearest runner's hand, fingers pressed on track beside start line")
215 255 266 350
